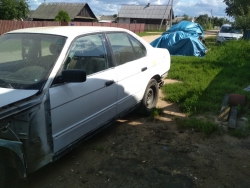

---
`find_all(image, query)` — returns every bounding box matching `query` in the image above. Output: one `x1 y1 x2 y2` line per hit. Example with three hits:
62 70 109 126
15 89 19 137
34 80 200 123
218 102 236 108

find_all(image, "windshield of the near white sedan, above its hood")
0 33 66 90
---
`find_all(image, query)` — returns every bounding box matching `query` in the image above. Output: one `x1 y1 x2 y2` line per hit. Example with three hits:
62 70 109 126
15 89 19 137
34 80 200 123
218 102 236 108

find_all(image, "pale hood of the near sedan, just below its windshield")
0 88 39 108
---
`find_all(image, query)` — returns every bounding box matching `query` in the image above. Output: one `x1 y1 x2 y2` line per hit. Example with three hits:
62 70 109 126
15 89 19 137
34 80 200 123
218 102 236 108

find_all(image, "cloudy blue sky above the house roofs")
28 0 226 17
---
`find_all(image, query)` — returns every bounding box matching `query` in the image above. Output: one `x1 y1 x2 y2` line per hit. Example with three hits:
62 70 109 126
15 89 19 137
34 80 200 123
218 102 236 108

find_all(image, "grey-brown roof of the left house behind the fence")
32 3 96 20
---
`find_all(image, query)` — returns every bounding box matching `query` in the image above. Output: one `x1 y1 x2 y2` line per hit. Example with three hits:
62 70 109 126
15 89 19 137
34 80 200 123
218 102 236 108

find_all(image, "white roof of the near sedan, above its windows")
8 26 127 37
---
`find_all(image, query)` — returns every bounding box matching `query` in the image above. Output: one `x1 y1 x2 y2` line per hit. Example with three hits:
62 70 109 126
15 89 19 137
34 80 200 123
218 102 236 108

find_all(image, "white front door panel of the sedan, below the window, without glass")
50 68 117 152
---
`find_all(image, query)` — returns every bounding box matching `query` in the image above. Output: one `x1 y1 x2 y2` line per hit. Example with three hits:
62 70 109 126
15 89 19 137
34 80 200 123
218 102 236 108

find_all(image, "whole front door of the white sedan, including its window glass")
49 34 117 153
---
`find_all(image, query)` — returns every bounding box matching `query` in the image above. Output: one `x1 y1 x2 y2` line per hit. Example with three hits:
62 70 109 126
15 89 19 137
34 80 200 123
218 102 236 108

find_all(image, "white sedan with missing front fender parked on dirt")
0 26 170 187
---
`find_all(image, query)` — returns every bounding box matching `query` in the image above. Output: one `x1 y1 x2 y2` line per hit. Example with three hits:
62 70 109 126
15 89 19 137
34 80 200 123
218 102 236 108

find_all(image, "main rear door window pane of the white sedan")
107 33 137 66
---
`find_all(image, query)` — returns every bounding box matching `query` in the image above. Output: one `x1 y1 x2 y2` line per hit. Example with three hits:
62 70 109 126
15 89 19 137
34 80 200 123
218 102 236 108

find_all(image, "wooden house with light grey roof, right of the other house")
117 3 174 24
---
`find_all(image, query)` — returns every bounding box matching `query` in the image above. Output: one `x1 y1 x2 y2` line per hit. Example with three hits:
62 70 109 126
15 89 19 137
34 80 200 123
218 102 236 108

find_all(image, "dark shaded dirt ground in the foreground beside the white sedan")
18 36 250 188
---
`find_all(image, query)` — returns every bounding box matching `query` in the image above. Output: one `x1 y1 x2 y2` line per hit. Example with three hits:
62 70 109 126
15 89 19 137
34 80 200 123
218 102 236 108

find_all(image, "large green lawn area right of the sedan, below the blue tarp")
163 41 250 114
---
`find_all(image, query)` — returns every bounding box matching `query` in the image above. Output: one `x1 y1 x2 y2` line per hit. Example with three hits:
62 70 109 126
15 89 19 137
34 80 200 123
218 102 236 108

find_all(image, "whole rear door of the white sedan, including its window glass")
107 32 149 114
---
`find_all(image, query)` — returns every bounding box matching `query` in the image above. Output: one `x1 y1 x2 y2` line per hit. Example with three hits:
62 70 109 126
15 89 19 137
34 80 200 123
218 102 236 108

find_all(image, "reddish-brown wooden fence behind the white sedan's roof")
0 20 145 35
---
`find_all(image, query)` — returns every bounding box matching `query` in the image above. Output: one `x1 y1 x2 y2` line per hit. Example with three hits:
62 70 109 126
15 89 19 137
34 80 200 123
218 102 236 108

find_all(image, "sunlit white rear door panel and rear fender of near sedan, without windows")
116 48 170 114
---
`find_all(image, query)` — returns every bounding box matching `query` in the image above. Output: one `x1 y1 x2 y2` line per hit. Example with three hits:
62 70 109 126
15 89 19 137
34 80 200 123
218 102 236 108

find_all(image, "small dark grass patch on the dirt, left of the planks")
176 117 219 136
